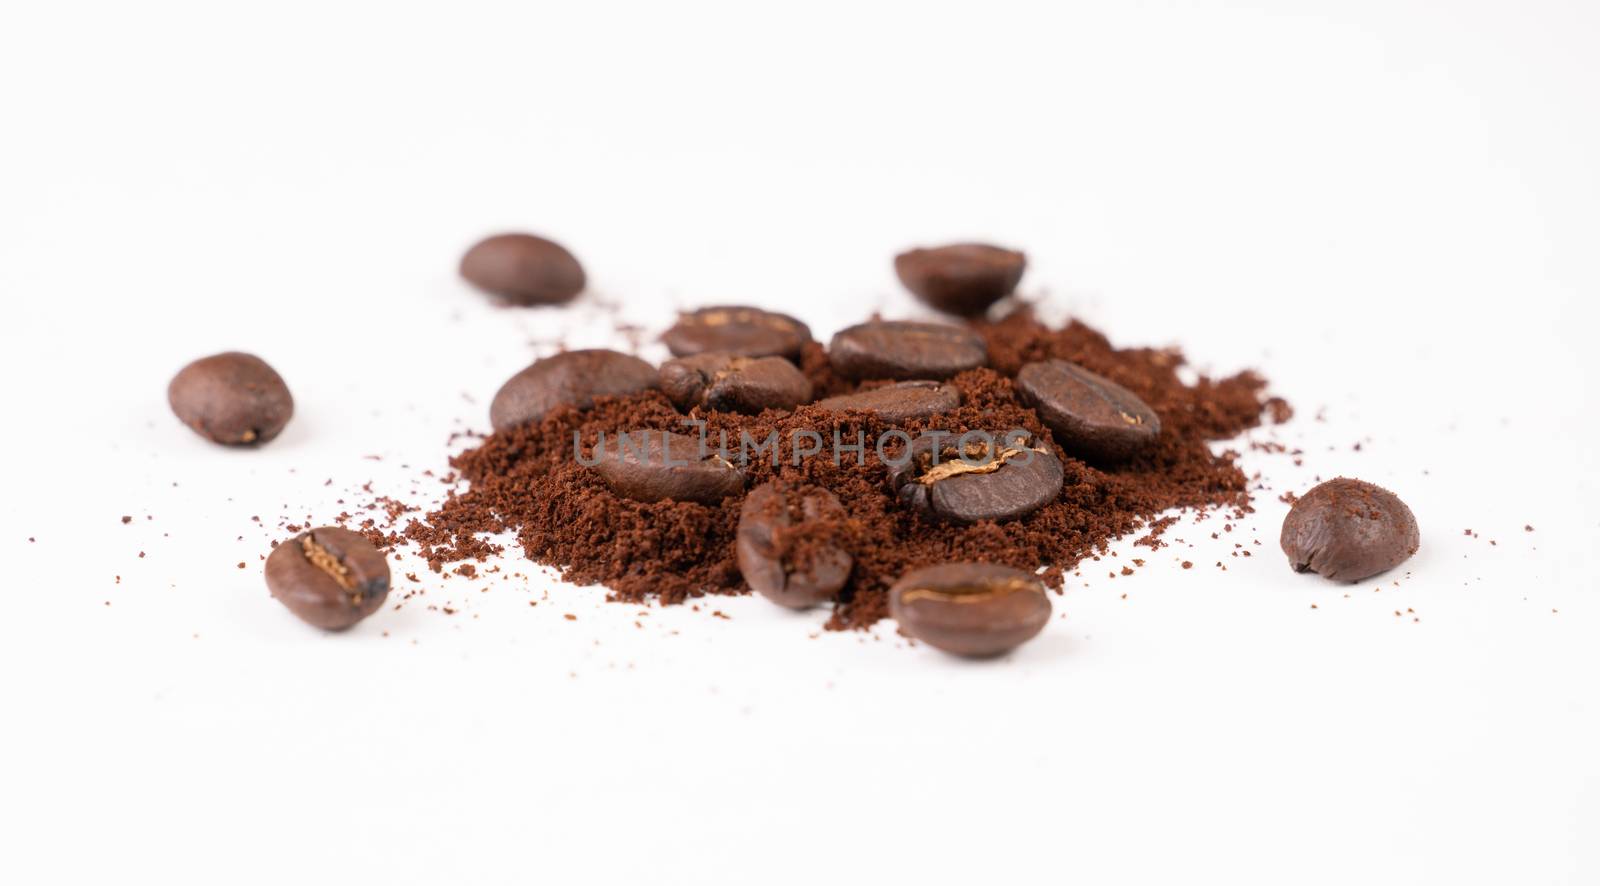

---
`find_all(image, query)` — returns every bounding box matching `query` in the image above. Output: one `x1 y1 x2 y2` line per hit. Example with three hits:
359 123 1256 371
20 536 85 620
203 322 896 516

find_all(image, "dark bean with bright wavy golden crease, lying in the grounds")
890 435 1062 523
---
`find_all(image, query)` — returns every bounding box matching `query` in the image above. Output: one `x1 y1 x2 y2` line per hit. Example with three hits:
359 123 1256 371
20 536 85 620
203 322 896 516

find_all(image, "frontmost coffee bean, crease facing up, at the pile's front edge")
890 563 1050 659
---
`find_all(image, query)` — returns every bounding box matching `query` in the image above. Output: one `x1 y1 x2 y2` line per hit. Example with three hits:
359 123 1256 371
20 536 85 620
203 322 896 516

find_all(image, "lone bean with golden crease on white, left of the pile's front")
267 526 389 630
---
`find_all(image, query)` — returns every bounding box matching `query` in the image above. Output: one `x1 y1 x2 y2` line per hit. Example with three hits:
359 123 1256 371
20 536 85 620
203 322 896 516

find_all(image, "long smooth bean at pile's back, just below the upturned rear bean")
827 320 989 381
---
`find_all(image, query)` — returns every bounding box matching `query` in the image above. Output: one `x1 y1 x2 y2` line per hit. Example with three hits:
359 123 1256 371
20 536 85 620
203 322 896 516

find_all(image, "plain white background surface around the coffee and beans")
0 0 1600 884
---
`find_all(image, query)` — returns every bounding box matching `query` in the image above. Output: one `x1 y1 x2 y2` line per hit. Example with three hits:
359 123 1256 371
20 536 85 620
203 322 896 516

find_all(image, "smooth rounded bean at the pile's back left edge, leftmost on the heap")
490 350 656 430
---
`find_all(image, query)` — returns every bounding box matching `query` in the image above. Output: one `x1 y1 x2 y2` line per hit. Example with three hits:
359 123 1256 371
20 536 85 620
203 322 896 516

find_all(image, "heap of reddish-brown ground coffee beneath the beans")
396 309 1288 629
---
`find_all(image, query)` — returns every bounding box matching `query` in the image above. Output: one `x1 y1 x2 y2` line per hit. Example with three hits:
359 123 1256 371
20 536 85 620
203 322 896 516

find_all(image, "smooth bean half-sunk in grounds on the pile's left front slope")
594 430 744 504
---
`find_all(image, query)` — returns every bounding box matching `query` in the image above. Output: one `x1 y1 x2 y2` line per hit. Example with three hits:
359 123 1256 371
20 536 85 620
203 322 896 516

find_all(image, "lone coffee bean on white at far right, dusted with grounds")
1278 477 1419 582
